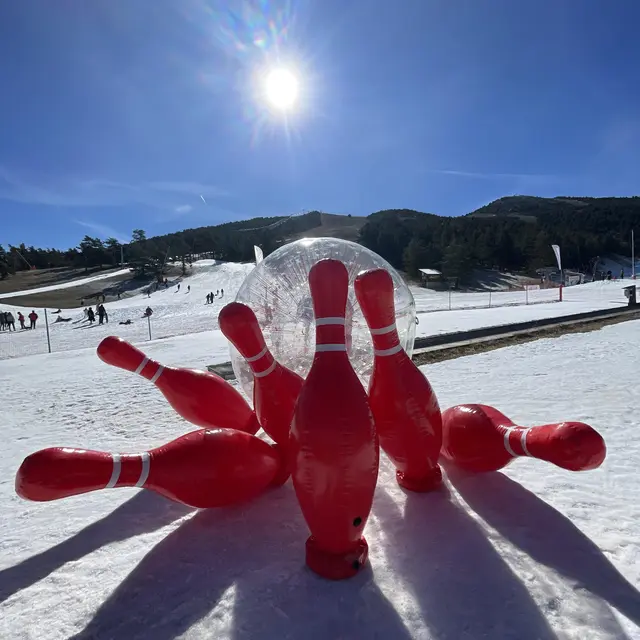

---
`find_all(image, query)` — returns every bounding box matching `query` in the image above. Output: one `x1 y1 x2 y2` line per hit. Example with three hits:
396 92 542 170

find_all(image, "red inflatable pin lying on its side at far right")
441 404 607 472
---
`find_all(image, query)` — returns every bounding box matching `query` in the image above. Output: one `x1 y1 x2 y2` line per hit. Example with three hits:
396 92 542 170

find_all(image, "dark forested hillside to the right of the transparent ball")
360 196 640 276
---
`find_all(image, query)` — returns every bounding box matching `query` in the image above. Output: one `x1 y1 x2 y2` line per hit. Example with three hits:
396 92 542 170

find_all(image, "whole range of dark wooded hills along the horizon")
0 196 640 277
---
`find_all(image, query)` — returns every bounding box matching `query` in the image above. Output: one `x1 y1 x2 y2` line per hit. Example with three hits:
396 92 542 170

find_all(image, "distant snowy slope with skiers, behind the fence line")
0 260 635 360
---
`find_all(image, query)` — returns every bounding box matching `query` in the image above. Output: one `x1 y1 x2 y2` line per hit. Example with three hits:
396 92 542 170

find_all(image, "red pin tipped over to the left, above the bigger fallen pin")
98 336 260 434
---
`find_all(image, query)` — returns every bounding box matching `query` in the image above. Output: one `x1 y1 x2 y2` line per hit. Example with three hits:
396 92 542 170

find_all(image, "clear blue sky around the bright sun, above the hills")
0 0 640 248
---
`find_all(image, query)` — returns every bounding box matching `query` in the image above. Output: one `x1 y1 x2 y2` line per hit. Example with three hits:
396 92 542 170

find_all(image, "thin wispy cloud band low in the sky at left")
0 167 230 210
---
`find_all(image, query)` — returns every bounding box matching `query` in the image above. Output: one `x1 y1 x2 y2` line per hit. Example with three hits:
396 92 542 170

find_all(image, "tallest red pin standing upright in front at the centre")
291 259 378 580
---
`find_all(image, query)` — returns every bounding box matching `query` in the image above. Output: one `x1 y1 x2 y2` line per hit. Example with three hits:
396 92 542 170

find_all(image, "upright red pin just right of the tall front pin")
354 269 442 491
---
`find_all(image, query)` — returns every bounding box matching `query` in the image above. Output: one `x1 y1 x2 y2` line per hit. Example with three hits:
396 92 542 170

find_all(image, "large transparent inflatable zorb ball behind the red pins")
230 238 416 398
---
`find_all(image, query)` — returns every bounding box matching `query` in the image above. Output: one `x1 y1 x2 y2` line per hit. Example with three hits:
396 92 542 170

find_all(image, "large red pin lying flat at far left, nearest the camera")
16 429 281 509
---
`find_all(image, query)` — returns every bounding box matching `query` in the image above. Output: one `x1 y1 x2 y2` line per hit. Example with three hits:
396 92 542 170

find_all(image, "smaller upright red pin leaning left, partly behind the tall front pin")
218 302 303 446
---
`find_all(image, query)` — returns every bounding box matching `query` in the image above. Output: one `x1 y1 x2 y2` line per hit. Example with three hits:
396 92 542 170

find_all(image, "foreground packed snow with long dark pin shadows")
0 314 640 640
